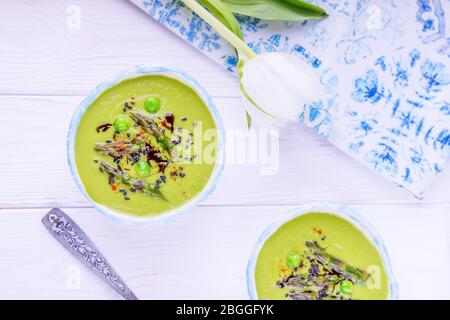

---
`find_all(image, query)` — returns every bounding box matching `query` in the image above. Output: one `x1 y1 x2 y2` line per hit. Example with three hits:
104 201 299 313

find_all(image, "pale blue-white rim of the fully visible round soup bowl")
67 66 225 225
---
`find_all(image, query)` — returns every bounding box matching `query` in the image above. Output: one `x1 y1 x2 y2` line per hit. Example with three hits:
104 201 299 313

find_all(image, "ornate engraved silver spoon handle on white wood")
42 208 138 300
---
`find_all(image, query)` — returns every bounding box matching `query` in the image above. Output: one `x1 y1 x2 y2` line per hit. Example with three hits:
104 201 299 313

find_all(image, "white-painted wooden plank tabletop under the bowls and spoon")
0 0 450 299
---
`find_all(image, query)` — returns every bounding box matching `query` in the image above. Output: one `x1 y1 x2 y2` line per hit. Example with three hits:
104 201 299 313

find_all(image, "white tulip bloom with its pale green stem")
183 0 323 126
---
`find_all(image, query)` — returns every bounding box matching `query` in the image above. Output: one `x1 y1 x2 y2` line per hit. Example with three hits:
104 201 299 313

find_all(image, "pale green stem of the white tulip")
181 0 256 59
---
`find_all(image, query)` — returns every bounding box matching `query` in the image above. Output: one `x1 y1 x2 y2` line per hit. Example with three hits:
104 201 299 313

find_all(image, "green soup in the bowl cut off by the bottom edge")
255 213 389 300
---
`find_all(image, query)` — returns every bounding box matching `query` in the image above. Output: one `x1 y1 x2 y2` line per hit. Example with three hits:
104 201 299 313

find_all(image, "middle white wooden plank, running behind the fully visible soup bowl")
0 96 450 208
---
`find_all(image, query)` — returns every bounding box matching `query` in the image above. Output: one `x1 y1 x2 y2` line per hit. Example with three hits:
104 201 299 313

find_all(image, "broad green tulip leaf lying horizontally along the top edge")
222 0 327 21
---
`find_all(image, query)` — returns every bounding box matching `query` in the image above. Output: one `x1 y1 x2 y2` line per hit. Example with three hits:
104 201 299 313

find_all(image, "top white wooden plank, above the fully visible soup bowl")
0 0 239 96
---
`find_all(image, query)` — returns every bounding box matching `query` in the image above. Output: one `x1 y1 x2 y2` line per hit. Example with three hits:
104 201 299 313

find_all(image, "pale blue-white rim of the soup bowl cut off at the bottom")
247 203 398 300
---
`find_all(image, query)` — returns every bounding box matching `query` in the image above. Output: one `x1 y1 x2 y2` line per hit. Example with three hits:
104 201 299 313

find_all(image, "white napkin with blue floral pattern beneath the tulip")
131 0 450 198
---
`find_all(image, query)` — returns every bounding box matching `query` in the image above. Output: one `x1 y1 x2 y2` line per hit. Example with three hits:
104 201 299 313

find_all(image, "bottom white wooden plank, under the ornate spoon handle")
0 205 450 299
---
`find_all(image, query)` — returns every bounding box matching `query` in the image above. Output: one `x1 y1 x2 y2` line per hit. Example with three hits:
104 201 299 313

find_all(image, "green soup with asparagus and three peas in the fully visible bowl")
75 75 217 216
